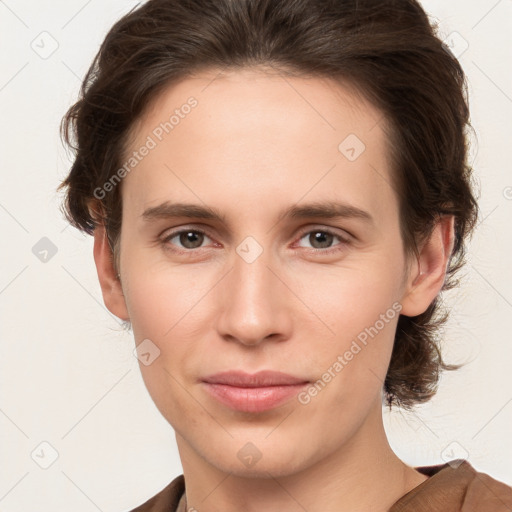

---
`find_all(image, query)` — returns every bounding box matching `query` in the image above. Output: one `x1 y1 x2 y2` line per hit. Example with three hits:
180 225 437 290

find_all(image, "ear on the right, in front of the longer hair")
400 215 454 316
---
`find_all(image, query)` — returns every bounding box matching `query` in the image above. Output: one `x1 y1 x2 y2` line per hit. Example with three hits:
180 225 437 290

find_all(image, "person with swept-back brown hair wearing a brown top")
57 0 512 512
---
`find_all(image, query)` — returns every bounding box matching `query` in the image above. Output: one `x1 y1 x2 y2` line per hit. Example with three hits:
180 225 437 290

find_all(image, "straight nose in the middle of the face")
217 245 293 346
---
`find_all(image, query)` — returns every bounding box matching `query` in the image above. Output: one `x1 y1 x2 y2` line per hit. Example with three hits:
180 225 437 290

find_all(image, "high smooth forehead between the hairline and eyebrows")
123 69 396 227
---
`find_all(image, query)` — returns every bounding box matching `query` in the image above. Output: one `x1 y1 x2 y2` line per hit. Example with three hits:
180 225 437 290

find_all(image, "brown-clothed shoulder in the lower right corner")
389 460 512 512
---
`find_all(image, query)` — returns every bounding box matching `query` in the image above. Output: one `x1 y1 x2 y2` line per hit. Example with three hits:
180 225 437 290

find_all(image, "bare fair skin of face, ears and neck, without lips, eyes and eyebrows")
94 68 453 512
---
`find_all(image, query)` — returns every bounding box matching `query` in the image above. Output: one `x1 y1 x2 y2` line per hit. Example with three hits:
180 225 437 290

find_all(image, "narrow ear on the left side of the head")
94 224 130 321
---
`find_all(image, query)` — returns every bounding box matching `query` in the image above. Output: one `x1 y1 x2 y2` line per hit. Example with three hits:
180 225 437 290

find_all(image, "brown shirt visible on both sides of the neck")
131 461 512 512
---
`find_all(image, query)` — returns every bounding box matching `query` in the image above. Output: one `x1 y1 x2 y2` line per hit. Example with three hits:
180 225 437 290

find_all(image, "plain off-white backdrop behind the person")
0 0 512 512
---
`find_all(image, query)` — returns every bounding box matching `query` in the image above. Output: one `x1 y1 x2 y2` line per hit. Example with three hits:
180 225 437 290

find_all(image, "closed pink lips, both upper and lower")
202 370 309 413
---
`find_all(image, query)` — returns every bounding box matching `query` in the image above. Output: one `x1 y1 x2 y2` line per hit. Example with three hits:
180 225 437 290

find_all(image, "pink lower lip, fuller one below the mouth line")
203 382 308 412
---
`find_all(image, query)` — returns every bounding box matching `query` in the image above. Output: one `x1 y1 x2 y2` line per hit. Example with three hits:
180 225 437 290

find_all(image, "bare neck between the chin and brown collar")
176 404 427 512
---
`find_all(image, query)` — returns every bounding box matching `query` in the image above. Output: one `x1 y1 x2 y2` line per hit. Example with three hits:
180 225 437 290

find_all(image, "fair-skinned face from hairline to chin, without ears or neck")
102 69 426 476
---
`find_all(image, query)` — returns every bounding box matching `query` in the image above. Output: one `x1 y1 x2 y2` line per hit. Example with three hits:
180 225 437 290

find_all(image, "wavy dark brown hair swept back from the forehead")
59 0 478 408
